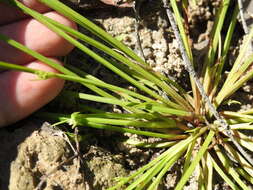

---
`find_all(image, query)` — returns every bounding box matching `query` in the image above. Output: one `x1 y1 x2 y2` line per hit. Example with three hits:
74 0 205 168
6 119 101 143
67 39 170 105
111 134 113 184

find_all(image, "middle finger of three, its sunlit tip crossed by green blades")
0 12 76 64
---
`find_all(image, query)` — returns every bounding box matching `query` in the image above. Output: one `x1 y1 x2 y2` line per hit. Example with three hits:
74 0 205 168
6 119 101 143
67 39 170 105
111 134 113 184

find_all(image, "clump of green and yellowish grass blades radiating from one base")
0 0 253 190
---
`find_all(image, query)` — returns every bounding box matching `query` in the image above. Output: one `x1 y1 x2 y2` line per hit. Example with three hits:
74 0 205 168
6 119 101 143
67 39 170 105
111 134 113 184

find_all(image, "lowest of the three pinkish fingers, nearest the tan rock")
0 58 64 127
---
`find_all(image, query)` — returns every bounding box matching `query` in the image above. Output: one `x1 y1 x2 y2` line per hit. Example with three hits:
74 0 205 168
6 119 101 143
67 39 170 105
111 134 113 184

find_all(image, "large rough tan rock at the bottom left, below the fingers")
9 124 85 190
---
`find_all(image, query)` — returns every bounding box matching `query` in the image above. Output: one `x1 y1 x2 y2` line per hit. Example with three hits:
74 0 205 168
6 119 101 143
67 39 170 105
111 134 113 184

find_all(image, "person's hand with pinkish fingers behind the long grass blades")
0 0 76 126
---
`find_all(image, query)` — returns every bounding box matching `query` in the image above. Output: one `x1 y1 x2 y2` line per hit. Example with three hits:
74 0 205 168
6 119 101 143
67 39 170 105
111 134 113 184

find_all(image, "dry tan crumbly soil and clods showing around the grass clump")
0 0 252 190
